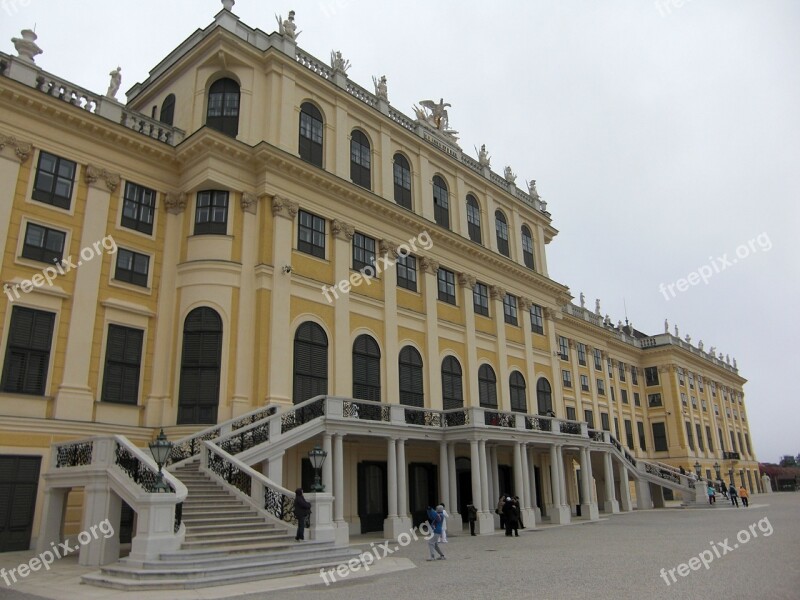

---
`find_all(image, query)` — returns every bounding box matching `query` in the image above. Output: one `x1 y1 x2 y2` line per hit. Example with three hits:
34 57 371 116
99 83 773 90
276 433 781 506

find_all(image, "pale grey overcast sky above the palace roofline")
0 0 800 461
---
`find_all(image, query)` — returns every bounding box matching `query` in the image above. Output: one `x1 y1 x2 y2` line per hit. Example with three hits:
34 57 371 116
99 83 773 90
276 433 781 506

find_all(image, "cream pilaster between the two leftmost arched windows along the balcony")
331 220 355 398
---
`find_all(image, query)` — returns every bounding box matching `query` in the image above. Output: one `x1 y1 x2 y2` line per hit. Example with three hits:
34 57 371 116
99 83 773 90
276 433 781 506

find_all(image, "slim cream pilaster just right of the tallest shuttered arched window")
231 192 259 420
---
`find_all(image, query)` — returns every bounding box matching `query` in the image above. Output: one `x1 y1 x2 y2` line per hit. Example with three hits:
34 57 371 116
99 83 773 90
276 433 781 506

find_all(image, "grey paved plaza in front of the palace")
0 493 800 600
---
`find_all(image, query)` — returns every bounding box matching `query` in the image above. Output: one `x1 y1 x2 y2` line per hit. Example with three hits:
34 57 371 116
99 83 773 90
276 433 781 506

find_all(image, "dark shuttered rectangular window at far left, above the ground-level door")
2 306 56 396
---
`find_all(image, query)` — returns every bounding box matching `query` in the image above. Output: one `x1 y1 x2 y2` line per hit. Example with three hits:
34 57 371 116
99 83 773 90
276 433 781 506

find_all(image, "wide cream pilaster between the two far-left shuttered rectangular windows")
53 165 121 421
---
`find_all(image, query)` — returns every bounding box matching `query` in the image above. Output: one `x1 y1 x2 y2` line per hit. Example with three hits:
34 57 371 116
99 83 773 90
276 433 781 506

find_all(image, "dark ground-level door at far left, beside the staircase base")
0 456 42 552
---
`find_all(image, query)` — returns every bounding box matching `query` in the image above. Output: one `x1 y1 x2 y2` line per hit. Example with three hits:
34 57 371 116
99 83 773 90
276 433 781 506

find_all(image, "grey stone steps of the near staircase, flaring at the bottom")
82 461 358 591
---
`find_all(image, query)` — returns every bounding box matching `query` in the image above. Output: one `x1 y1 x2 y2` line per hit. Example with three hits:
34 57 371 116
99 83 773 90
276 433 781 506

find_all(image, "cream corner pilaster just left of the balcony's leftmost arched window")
267 196 299 404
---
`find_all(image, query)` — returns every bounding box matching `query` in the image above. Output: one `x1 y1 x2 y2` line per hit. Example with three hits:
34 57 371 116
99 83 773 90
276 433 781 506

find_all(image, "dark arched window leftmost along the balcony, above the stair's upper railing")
292 322 328 404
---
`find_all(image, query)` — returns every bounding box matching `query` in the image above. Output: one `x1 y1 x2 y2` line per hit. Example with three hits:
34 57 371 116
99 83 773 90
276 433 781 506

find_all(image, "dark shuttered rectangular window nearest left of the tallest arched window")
102 325 144 405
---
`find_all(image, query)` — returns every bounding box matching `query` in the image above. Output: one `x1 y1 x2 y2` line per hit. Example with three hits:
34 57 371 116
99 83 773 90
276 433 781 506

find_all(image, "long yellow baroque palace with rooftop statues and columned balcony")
0 0 760 584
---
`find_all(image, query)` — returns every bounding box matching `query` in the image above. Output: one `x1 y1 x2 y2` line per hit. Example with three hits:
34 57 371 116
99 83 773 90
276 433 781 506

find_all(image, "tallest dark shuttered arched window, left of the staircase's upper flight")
178 307 222 425
